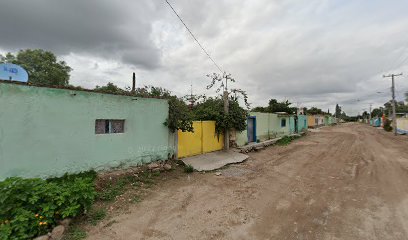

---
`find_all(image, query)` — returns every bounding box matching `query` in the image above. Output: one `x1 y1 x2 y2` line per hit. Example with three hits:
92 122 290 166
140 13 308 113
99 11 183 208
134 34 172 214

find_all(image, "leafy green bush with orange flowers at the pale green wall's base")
0 173 96 240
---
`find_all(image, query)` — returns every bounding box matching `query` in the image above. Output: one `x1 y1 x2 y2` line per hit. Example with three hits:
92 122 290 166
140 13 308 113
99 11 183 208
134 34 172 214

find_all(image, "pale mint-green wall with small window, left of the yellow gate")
0 83 174 179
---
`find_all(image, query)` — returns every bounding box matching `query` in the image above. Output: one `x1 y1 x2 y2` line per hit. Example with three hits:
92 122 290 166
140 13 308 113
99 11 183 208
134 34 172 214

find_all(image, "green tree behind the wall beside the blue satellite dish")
0 49 72 86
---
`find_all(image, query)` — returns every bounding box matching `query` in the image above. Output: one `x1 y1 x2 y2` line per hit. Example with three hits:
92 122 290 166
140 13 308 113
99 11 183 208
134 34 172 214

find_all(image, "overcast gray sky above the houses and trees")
0 0 408 114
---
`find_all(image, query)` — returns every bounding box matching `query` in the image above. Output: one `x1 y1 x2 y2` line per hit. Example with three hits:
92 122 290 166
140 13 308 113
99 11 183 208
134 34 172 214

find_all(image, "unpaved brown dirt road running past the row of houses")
89 124 408 240
